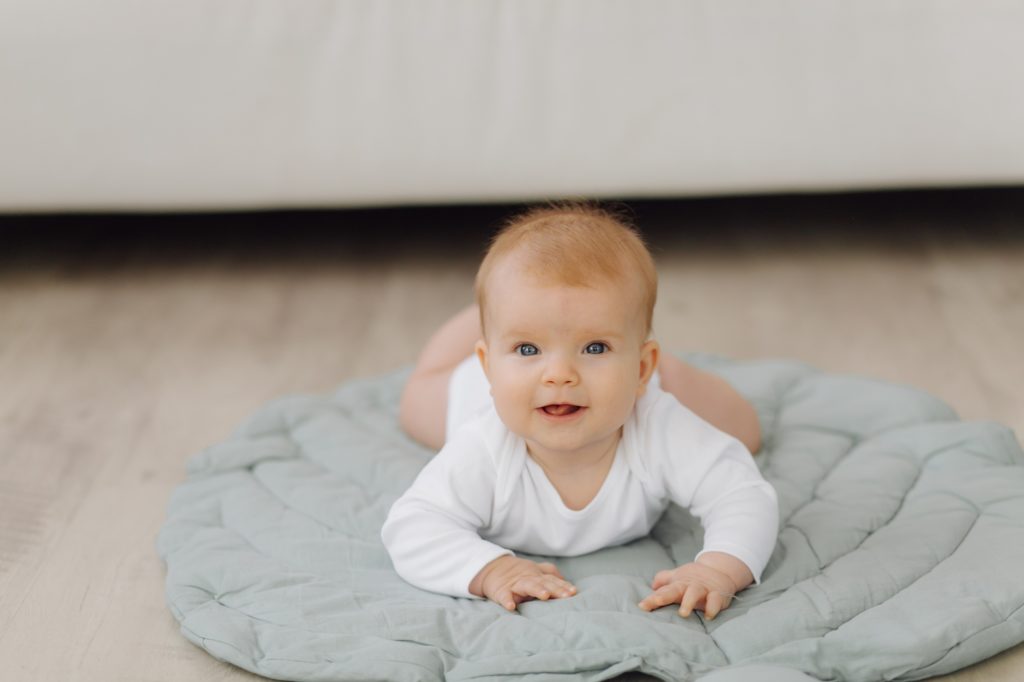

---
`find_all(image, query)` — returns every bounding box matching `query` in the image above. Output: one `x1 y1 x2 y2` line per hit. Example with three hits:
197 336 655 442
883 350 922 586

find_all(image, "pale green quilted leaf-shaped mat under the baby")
158 355 1024 681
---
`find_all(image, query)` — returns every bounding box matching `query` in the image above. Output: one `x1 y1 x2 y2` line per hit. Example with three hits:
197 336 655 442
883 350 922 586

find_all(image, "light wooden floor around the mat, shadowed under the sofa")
6 189 1024 682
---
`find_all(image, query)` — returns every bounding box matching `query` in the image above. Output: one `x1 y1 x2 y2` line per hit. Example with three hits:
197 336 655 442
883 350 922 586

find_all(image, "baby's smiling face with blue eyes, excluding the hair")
477 260 658 458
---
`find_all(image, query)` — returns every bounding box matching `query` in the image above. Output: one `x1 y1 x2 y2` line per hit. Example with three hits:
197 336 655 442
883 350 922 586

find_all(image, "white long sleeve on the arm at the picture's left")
381 428 512 597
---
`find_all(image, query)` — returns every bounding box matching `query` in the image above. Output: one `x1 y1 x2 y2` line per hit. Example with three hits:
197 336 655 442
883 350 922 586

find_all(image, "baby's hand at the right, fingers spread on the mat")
639 552 754 621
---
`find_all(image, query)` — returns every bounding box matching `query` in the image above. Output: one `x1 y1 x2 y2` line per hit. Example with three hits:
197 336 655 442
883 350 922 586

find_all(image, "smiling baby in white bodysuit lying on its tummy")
382 205 778 619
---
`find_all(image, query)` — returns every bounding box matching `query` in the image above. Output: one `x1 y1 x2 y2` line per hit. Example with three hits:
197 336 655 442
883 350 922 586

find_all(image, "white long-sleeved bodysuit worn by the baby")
381 357 778 597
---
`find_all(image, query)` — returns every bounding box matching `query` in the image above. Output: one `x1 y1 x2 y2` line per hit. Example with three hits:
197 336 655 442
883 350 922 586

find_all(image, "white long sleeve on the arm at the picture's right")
646 395 778 583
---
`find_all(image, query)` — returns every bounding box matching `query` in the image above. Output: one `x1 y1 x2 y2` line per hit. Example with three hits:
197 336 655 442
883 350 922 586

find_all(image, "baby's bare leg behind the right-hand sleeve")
657 353 761 453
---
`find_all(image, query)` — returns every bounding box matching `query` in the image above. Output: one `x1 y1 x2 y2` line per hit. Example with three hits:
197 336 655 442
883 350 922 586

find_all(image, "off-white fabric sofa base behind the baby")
0 0 1024 213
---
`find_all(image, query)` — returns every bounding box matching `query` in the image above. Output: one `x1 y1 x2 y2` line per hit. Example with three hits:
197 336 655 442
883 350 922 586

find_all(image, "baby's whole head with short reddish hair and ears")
476 199 658 456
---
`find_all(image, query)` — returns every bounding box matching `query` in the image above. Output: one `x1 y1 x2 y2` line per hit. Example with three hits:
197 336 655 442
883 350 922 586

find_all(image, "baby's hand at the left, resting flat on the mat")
469 555 577 611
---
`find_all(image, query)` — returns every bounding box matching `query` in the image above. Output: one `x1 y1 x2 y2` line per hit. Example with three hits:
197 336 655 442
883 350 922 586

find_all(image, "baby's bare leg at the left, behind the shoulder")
398 305 480 450
